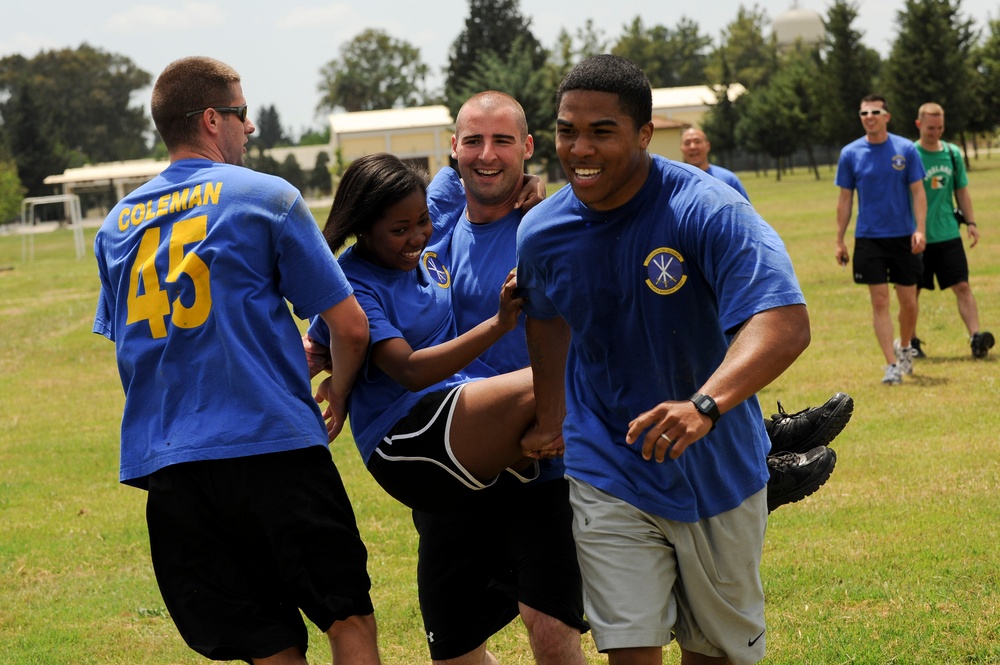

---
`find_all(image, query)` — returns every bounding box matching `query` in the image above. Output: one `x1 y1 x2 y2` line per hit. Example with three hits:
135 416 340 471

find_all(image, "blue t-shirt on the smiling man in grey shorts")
517 155 804 522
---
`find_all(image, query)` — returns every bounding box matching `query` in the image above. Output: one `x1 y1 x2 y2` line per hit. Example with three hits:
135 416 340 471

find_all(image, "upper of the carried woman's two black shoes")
764 393 854 455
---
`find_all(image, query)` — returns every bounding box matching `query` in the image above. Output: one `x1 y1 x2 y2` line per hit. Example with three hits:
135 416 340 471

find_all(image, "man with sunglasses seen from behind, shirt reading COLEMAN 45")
94 57 379 665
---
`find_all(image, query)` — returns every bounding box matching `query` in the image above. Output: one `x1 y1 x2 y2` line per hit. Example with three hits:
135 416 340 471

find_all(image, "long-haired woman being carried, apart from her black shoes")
309 153 562 512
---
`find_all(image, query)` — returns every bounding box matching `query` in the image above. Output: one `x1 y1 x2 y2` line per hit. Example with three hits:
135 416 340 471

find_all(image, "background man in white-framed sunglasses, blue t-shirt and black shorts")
836 95 927 385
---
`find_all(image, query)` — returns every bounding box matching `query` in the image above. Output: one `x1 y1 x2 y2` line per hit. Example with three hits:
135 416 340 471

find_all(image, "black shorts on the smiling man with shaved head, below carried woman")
413 478 589 660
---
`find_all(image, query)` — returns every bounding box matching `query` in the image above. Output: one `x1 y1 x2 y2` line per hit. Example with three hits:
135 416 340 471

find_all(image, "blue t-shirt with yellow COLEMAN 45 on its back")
94 159 351 487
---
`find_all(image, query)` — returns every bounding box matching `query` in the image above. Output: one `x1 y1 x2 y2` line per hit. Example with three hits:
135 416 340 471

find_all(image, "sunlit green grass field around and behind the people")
0 160 1000 665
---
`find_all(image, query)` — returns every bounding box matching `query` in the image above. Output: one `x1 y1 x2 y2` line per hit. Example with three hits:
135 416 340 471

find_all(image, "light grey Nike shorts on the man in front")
569 478 767 665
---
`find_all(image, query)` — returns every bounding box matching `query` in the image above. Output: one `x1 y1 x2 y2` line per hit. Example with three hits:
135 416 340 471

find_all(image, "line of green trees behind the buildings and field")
0 0 1000 222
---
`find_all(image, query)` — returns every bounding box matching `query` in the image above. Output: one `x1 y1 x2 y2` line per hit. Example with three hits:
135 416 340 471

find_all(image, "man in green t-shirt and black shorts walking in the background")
913 103 994 358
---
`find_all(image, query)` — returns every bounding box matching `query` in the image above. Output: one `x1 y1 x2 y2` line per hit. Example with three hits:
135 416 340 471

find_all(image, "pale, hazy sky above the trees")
0 0 1000 135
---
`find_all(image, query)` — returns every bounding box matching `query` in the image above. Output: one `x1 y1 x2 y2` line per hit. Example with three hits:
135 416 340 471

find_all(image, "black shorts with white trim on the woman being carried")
368 384 538 514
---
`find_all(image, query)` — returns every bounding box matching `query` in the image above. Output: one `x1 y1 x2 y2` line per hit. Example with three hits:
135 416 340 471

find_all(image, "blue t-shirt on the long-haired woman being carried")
309 247 496 464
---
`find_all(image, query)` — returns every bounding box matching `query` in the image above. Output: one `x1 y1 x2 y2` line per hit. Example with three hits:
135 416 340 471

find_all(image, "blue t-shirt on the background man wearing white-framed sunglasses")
836 133 924 238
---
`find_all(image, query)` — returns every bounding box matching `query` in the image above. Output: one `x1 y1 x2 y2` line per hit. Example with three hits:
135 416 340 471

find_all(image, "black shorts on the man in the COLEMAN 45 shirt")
146 446 373 662
